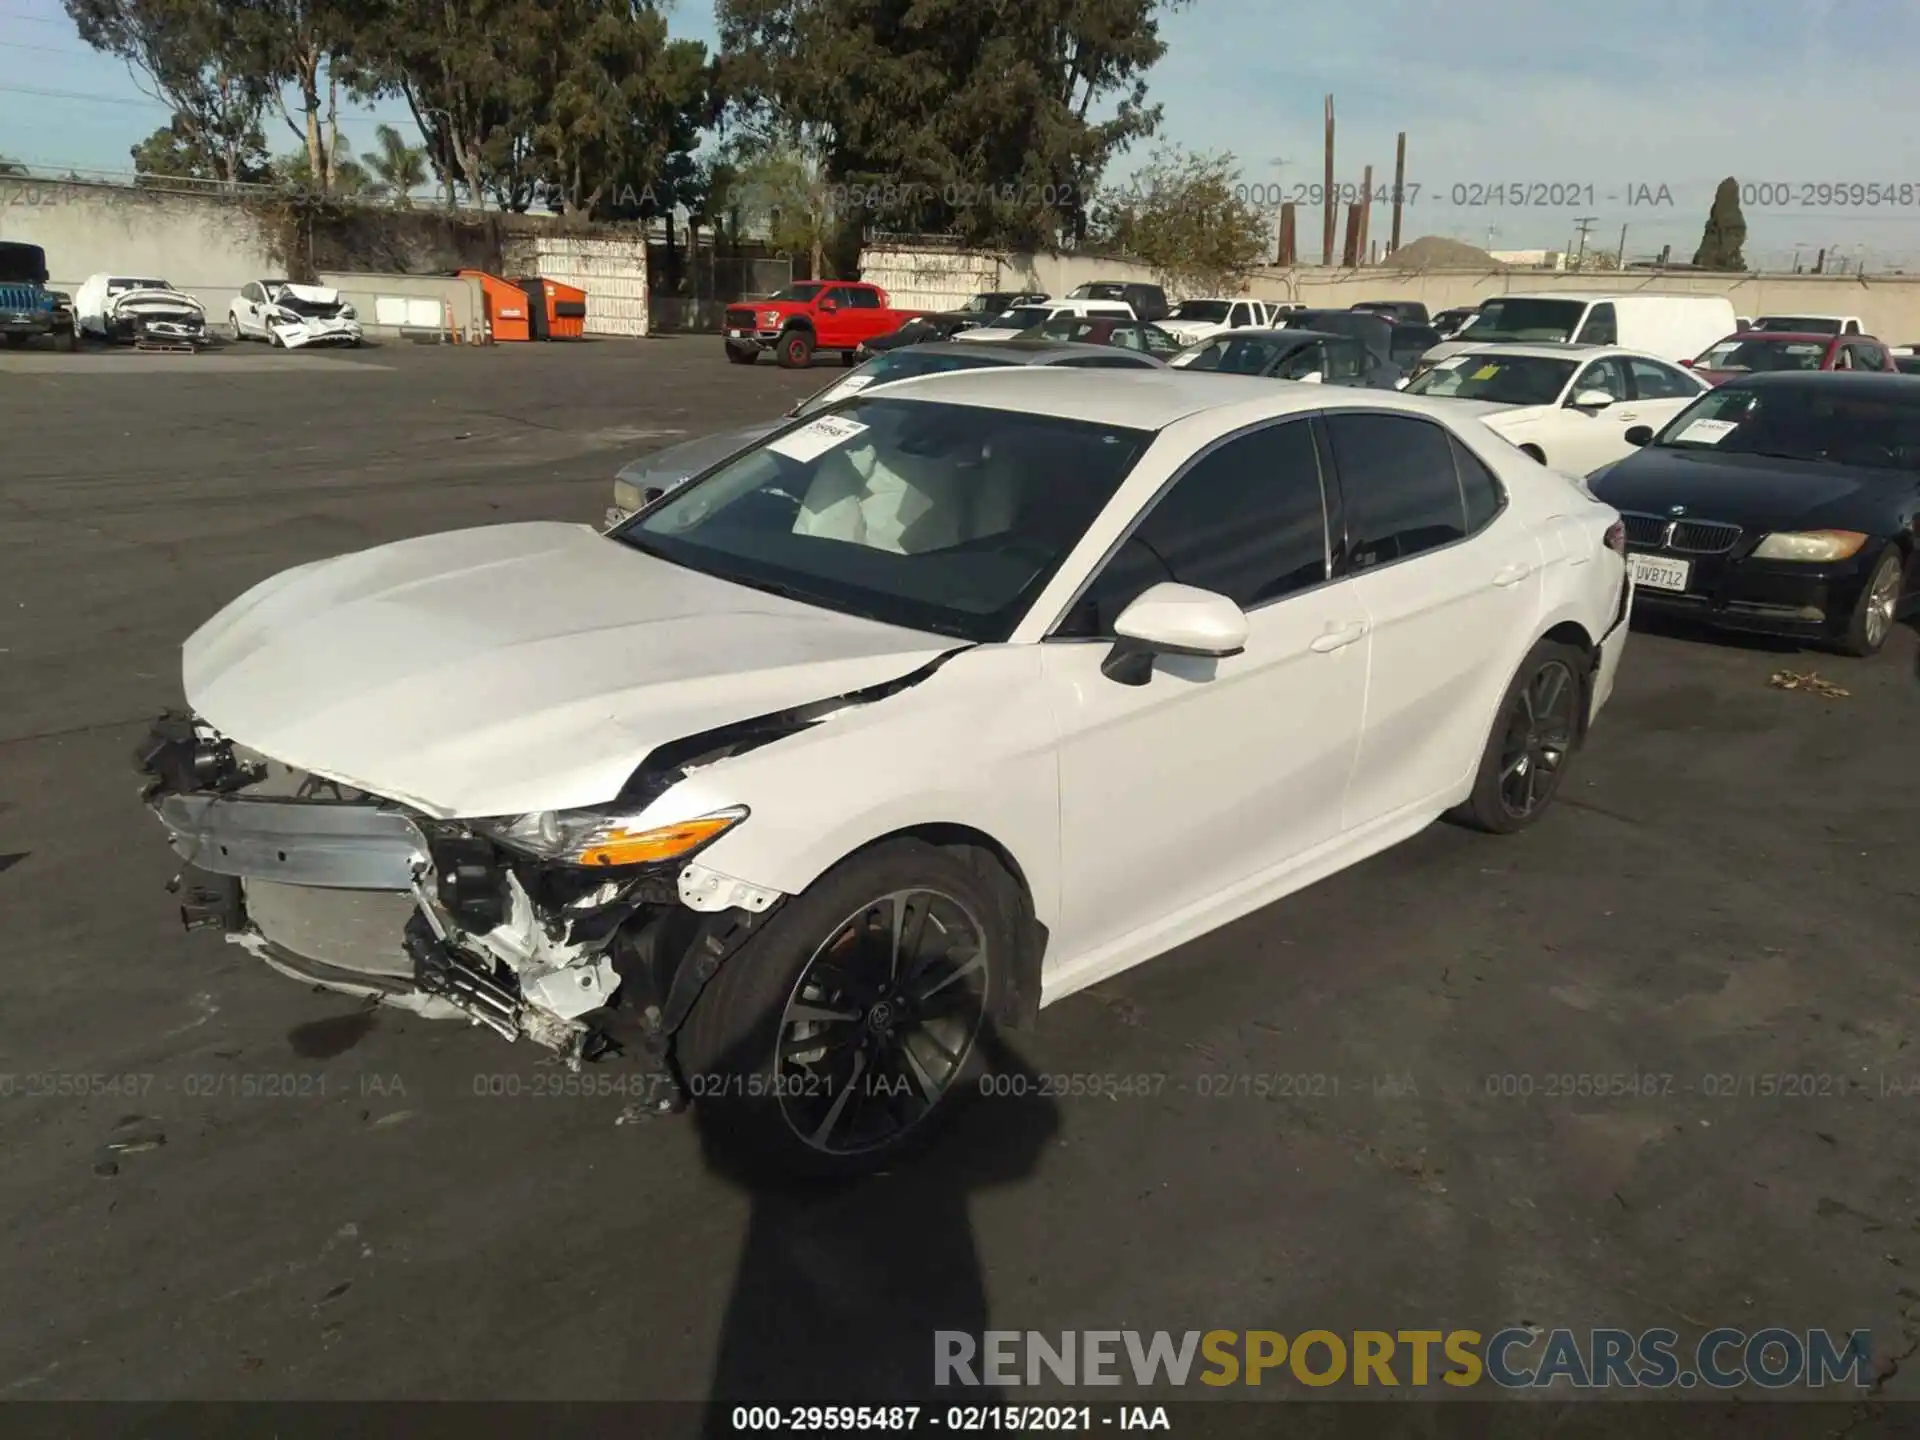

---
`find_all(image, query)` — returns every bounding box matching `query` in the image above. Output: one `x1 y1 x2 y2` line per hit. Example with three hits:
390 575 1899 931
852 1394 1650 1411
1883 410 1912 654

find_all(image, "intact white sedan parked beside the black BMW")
1404 344 1713 474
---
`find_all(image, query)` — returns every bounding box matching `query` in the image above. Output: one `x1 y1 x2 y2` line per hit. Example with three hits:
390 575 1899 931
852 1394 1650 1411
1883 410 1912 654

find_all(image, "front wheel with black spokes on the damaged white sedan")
676 839 1020 1175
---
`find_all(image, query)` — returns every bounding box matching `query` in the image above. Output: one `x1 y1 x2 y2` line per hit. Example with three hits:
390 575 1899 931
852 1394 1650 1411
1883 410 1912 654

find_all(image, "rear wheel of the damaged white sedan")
1452 639 1588 835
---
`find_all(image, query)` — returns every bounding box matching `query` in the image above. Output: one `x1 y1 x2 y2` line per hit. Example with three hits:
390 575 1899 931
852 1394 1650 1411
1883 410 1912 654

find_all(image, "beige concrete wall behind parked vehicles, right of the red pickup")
860 246 1920 346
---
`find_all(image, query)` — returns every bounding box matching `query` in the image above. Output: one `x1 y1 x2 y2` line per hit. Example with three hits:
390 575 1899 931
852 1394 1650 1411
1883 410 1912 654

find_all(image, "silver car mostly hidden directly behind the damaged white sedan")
607 340 1165 526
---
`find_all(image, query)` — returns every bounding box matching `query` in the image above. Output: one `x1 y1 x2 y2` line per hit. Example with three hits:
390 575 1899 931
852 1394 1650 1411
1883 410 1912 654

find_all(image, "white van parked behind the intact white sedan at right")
1421 290 1736 367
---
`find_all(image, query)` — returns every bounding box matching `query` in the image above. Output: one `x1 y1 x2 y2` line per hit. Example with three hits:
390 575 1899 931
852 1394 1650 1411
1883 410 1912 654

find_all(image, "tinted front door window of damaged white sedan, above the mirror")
1060 420 1327 636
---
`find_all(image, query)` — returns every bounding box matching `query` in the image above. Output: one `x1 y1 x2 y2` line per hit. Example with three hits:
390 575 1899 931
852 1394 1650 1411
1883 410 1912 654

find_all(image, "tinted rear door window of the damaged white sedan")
1327 413 1467 570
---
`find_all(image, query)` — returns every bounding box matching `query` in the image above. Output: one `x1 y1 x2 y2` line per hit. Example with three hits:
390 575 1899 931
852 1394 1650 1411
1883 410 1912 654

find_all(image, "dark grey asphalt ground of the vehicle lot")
0 338 1920 1400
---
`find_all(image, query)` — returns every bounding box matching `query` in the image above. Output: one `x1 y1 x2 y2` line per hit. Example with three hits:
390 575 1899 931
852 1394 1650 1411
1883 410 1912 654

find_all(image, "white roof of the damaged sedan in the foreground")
864 367 1459 430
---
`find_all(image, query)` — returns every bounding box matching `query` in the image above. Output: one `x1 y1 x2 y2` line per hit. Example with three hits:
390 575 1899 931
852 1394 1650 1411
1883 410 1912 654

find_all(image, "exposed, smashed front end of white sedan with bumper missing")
134 714 705 1066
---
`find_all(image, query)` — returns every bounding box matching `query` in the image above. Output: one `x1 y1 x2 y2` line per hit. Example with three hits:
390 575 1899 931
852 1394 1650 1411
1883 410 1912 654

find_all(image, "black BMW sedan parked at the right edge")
1588 372 1920 655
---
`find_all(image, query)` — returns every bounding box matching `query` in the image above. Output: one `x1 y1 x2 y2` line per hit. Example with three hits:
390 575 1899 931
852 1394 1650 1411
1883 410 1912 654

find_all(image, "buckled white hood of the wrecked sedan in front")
182 522 956 816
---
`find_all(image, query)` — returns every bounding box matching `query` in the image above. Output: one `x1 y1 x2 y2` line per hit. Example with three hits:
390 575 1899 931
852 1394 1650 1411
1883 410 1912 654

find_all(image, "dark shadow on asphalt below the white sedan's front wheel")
693 1031 1060 1436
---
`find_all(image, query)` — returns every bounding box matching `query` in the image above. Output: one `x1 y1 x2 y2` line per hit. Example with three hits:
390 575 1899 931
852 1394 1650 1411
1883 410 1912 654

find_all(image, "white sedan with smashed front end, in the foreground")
138 369 1632 1171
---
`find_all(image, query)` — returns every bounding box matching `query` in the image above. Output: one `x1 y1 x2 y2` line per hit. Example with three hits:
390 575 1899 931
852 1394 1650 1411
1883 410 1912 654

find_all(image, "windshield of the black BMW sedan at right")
1653 380 1920 470
